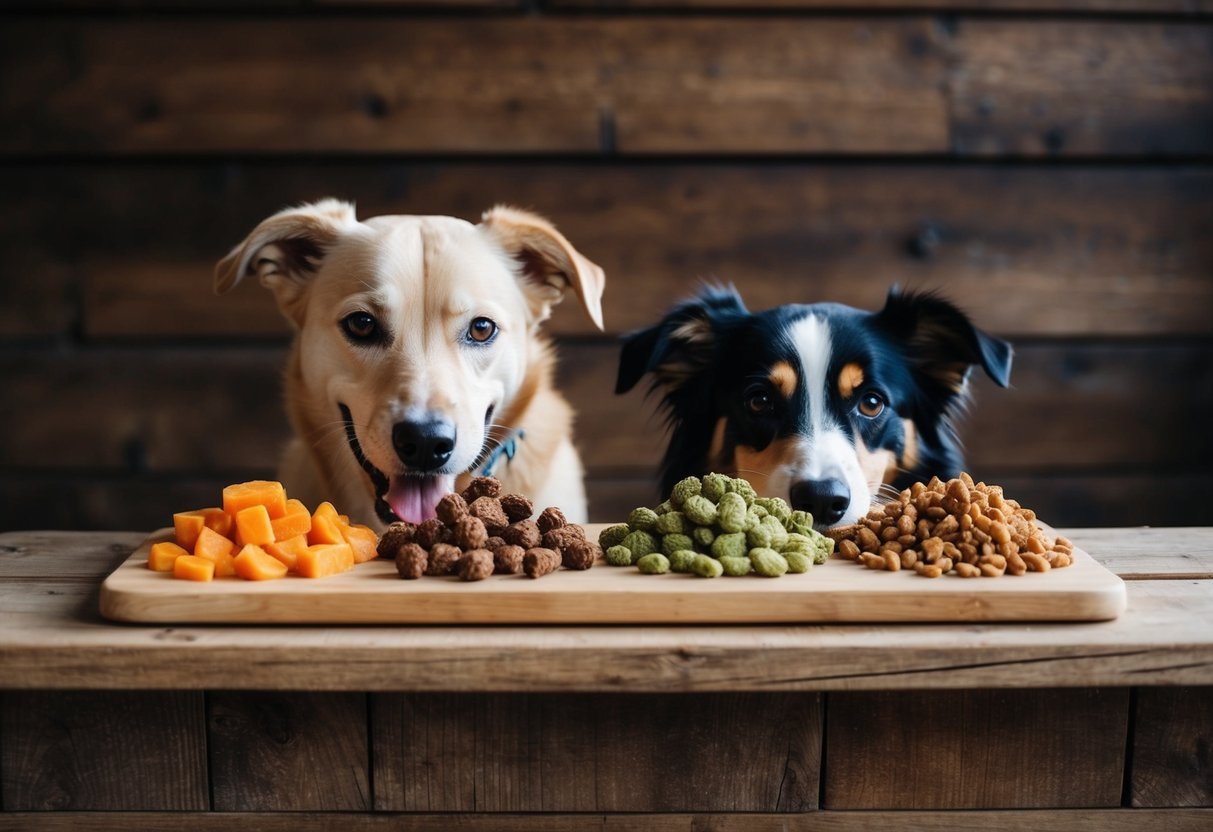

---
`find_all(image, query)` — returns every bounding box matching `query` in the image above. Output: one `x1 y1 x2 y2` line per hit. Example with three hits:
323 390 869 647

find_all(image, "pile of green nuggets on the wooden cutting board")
598 473 835 577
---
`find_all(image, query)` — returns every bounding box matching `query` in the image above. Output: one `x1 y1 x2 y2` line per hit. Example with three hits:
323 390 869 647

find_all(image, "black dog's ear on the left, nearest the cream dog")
615 286 750 393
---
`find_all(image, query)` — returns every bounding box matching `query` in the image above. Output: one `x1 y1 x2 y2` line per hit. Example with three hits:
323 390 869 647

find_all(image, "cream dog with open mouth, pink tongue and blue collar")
215 200 604 526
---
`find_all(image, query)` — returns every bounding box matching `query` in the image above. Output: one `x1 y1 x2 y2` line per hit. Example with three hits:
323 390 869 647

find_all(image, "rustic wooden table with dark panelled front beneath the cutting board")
0 529 1213 832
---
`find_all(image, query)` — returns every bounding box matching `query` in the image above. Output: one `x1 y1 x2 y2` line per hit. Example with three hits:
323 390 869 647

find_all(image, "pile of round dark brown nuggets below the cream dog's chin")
378 477 602 581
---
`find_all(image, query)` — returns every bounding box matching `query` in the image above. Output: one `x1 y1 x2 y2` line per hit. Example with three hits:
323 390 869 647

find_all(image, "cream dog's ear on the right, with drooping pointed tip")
480 205 607 329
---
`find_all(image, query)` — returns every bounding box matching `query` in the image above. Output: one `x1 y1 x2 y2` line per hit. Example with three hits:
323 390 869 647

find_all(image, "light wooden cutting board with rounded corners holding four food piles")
101 524 1126 625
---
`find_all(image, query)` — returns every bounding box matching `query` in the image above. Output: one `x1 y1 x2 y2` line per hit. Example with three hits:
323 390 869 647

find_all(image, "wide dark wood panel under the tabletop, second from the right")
822 688 1129 809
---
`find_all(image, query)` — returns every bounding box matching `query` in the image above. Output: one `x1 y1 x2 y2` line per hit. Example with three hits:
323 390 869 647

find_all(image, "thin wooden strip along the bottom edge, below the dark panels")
0 809 1213 832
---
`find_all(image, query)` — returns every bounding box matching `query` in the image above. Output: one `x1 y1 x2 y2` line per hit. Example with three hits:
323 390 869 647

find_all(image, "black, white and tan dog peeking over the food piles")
615 287 1012 529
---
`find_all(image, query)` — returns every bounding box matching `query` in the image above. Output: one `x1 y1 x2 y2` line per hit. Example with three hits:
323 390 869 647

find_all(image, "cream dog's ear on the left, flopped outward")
215 199 358 323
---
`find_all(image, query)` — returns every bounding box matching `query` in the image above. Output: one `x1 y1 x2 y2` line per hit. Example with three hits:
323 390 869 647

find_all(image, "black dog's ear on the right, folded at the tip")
876 286 1012 394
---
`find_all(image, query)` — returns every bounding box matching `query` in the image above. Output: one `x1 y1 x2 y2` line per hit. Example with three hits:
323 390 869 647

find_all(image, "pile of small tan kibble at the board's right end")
828 473 1074 577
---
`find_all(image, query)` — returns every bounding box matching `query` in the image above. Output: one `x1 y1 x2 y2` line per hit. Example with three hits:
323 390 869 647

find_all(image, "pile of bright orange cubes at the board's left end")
148 479 378 581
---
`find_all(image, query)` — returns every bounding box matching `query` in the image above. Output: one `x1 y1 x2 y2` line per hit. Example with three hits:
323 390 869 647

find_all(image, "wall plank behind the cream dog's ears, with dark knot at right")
0 160 1213 340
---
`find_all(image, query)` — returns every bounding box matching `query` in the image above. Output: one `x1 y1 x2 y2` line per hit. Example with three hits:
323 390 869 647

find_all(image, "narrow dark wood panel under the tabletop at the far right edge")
1129 688 1213 807
